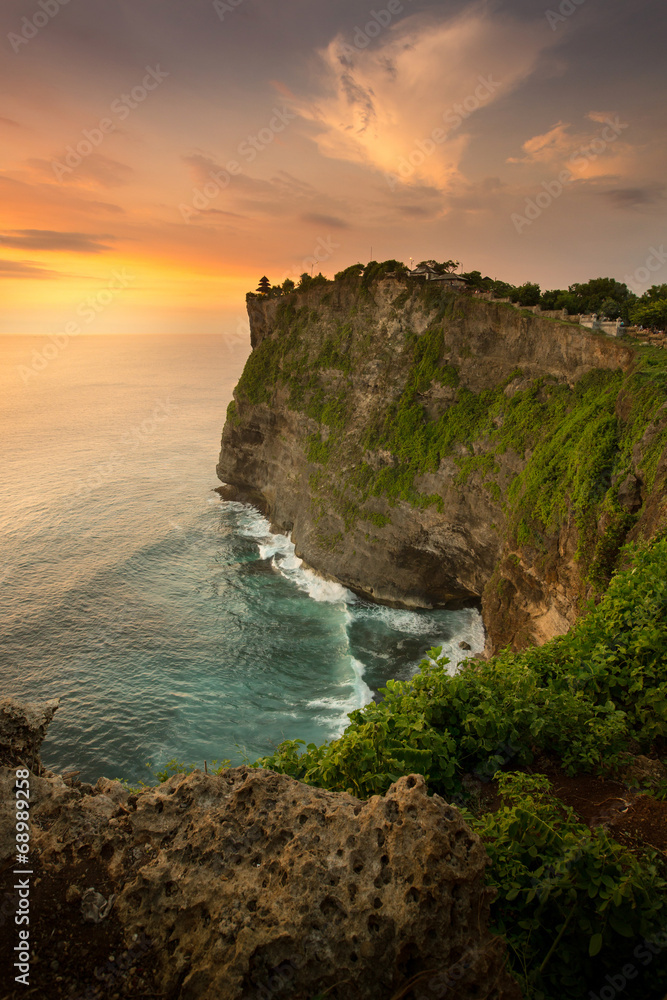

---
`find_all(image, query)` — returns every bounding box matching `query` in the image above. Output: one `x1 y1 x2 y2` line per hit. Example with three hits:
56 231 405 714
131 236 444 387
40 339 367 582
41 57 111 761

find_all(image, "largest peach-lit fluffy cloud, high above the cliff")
294 5 550 192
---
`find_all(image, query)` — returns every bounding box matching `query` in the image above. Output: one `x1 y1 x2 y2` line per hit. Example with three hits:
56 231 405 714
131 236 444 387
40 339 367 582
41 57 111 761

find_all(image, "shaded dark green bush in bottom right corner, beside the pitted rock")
468 774 667 1000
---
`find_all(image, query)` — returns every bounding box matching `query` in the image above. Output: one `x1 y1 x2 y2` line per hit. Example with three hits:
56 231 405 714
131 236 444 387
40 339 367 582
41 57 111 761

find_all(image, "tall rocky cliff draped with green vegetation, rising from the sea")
217 266 667 651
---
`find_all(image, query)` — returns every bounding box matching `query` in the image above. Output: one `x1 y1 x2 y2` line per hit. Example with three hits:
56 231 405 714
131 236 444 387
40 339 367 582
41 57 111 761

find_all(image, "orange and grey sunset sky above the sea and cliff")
0 0 667 336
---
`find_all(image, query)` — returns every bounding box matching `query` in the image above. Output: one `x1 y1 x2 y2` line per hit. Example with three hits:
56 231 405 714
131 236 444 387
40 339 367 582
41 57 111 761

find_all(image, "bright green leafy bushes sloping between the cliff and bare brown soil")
258 538 667 796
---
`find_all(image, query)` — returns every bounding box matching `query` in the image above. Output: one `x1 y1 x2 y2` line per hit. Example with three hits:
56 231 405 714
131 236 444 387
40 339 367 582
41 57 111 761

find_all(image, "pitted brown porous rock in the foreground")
0 700 518 1000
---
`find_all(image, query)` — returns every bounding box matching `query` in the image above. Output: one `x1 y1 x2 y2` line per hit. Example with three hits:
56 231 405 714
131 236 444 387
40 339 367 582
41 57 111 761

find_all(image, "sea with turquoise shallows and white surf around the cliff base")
0 336 483 781
